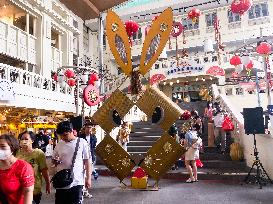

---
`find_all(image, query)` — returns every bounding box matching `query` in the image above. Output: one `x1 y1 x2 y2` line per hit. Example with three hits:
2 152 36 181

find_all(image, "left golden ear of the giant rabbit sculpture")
106 11 132 76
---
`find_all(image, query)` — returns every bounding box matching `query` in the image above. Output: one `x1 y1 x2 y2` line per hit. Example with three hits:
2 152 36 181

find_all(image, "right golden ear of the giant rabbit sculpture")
139 8 173 75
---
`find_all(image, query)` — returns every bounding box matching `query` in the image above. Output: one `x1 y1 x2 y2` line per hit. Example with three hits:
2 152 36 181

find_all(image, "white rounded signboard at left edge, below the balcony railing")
0 79 15 101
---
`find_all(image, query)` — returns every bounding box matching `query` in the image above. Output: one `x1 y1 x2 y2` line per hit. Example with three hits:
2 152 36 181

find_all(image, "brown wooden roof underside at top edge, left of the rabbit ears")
60 0 128 20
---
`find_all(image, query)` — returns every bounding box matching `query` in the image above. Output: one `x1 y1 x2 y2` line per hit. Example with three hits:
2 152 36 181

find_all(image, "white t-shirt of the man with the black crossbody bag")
53 138 90 189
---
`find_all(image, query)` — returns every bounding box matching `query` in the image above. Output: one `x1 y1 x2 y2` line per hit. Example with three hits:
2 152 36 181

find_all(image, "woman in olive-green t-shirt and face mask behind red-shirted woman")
17 131 50 204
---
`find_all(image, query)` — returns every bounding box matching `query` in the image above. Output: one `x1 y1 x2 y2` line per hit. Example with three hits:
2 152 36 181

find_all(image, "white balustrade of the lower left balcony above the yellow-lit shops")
0 63 73 95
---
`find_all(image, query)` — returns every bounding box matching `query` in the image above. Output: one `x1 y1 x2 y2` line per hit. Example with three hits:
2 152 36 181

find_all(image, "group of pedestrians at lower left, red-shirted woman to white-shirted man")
0 121 98 204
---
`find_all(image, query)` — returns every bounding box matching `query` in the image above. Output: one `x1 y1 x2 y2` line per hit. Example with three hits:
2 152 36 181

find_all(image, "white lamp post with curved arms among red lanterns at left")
57 66 98 116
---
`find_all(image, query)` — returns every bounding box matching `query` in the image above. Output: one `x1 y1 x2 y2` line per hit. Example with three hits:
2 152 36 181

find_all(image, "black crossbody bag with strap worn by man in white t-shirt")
51 138 80 188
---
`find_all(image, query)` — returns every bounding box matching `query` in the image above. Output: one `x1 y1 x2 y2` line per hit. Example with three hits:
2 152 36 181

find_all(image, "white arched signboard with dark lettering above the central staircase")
166 61 204 76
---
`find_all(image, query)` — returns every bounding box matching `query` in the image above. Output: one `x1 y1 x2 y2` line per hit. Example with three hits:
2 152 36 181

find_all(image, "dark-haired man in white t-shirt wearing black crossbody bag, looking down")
53 121 92 204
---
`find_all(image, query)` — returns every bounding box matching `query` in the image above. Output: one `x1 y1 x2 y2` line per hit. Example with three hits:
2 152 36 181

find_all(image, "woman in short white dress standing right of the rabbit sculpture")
184 127 202 183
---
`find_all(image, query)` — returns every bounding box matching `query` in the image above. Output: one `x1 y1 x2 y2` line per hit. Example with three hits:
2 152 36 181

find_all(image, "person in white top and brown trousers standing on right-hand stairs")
213 110 226 154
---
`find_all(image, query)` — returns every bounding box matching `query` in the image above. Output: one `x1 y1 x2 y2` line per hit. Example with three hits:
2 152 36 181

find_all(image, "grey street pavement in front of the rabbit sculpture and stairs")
41 176 273 204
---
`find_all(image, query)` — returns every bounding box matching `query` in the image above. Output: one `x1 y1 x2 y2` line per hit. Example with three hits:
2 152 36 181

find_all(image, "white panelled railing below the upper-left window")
0 21 36 65
